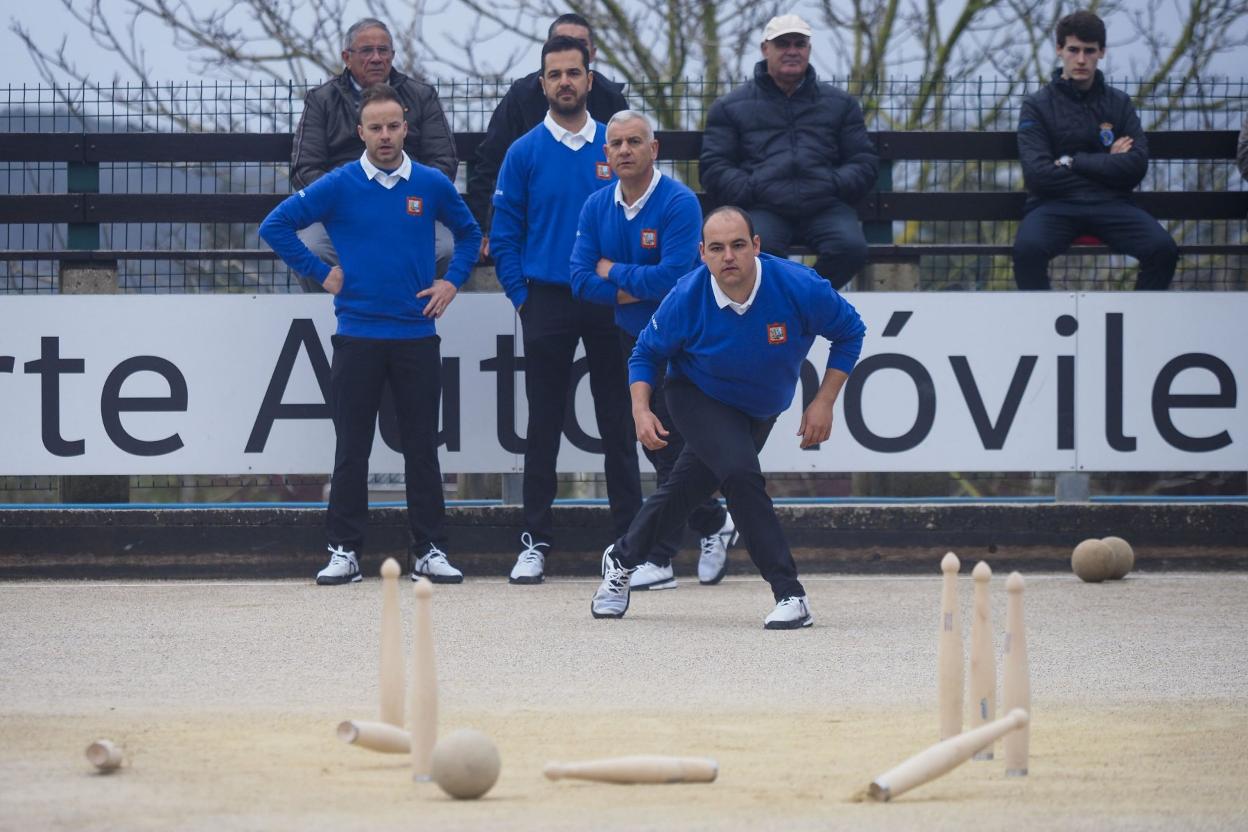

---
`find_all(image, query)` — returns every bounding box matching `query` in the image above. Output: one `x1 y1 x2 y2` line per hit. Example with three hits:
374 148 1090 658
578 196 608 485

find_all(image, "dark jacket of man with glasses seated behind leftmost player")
291 70 459 188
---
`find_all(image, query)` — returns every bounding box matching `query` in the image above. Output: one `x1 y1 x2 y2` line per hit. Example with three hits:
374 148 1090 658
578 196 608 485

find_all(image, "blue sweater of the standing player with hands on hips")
260 162 480 339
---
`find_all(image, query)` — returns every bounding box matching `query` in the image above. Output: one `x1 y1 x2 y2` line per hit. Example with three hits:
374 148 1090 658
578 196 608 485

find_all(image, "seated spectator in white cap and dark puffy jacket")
701 15 880 288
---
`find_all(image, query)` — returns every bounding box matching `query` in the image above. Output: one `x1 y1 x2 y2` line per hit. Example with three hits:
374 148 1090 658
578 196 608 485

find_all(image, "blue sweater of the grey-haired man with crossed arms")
572 176 701 338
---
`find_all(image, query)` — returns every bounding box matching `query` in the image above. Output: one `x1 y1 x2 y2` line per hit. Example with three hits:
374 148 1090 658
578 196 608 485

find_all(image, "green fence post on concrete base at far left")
60 146 130 503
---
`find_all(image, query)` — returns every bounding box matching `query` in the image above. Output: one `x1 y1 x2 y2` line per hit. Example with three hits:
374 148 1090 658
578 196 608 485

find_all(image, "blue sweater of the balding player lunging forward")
629 254 866 419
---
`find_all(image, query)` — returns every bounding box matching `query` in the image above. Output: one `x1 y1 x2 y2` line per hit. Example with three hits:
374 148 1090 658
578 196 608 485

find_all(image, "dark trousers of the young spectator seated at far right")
1013 200 1178 289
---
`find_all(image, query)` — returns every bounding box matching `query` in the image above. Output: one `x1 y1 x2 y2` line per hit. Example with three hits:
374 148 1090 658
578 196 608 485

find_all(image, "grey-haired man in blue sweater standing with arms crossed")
572 110 736 590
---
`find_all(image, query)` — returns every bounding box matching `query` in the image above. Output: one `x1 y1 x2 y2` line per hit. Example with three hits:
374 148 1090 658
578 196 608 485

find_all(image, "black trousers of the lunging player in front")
615 379 806 601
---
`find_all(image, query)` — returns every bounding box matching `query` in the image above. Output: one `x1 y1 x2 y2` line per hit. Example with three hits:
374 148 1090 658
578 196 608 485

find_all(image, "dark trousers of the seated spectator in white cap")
750 202 867 289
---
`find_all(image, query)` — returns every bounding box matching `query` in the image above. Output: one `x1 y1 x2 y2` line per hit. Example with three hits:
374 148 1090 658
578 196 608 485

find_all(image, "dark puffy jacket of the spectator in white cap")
700 61 880 216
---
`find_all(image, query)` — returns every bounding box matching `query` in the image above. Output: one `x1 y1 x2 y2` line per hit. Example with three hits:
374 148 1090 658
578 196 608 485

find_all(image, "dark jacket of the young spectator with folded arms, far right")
1018 70 1148 208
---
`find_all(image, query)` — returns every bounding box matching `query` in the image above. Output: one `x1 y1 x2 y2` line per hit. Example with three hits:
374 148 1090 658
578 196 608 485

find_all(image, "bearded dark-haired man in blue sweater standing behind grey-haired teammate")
490 35 641 584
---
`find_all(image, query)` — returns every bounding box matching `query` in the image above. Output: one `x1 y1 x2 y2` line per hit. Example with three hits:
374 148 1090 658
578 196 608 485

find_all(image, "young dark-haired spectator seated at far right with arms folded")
1013 11 1178 289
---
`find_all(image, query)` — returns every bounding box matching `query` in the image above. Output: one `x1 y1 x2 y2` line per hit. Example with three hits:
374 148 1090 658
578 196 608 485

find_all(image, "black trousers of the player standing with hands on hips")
326 336 446 554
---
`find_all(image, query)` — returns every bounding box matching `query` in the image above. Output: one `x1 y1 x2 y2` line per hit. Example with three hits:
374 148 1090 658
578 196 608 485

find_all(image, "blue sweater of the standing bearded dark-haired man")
489 121 615 309
